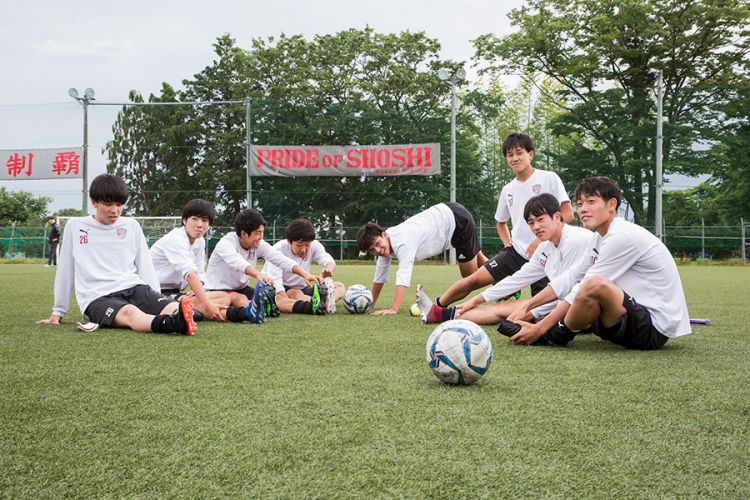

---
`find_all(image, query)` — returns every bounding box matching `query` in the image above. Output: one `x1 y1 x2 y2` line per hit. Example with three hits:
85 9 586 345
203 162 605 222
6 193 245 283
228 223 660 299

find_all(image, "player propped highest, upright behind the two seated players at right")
424 133 573 306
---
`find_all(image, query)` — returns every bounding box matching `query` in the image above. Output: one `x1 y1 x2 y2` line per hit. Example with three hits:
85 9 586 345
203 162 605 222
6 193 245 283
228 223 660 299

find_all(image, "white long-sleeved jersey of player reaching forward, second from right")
482 224 594 318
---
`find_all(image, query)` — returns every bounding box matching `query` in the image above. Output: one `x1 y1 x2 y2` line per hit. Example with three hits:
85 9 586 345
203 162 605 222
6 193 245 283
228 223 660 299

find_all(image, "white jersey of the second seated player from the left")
151 226 206 290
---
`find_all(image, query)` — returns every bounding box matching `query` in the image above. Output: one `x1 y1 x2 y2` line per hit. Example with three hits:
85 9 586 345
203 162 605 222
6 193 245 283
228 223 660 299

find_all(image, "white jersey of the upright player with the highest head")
495 169 570 259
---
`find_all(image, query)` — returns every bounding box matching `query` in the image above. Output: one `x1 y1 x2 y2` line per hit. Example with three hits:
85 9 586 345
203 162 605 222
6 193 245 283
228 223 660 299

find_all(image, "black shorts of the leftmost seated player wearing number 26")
83 285 177 326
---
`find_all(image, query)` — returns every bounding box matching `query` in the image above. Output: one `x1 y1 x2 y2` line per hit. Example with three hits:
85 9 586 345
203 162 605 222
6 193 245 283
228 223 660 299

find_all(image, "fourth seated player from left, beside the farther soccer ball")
262 219 345 314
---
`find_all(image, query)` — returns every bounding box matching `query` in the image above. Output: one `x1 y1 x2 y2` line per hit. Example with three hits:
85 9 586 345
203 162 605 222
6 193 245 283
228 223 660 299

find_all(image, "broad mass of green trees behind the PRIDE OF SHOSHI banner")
107 28 496 227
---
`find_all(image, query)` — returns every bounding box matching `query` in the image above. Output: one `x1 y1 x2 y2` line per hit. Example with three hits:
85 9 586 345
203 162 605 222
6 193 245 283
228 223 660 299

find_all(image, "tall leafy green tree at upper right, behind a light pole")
475 0 750 223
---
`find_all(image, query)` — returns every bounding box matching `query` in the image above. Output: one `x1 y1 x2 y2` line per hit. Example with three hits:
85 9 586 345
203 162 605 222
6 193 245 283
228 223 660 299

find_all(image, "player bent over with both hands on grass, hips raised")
357 203 487 315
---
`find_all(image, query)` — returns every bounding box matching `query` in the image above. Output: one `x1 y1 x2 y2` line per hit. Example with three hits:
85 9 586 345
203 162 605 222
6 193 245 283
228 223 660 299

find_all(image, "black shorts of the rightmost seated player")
594 292 669 350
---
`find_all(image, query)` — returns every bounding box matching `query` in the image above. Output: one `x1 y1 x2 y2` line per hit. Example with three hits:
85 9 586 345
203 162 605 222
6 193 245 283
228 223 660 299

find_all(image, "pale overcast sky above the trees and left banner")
0 0 704 210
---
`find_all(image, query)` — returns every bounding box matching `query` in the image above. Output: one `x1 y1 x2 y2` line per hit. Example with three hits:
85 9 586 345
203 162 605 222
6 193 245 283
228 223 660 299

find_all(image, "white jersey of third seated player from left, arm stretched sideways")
205 232 302 290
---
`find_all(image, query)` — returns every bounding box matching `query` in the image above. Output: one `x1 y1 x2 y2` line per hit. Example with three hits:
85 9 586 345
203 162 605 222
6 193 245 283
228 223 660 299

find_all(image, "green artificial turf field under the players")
0 264 750 498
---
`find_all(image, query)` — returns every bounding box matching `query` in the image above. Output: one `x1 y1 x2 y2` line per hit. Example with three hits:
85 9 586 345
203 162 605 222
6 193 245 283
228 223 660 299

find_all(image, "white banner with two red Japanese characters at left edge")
0 148 83 181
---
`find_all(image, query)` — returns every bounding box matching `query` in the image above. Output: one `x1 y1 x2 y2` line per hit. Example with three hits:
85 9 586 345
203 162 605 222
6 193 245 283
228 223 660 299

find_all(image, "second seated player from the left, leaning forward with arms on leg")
151 200 250 322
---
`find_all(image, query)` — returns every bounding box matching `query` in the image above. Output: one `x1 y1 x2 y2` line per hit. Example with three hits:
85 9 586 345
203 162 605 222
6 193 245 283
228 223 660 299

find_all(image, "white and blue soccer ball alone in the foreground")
427 319 492 385
